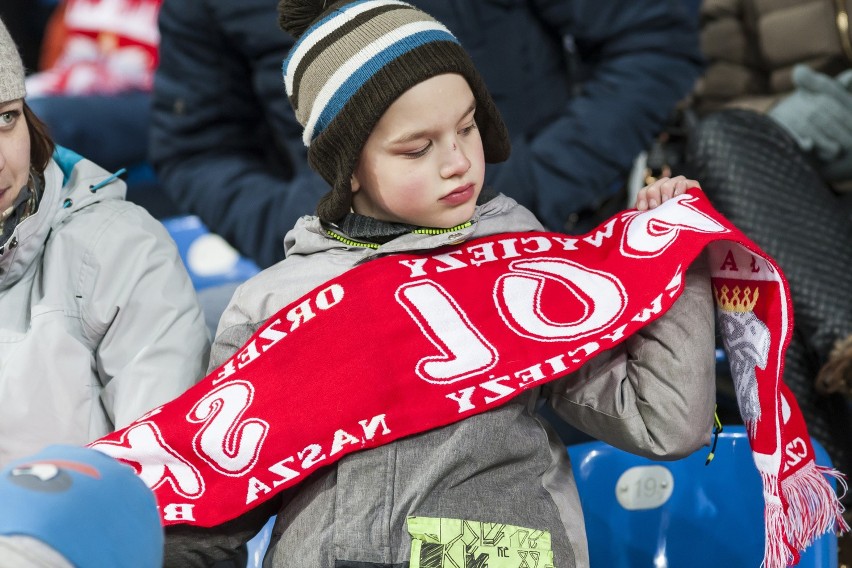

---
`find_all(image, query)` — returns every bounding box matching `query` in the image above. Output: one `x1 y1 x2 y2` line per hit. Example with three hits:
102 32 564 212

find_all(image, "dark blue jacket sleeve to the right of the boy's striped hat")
489 0 702 231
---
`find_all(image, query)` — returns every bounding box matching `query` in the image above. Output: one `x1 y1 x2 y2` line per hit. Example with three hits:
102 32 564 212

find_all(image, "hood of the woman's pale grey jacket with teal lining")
0 146 127 291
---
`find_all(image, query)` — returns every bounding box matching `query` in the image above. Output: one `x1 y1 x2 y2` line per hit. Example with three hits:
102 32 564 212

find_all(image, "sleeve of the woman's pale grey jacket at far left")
80 201 210 428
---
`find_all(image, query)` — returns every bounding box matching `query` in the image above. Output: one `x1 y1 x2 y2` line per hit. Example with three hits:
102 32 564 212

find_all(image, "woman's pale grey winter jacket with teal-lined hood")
0 148 209 466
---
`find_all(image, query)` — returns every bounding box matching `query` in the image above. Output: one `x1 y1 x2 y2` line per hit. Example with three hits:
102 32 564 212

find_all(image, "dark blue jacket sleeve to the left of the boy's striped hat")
149 0 329 267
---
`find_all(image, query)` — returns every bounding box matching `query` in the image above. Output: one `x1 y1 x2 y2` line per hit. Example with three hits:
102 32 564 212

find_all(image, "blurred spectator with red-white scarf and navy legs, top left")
27 0 176 217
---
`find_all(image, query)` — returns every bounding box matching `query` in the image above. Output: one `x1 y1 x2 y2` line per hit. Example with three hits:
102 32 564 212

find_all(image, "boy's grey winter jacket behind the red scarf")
166 196 715 568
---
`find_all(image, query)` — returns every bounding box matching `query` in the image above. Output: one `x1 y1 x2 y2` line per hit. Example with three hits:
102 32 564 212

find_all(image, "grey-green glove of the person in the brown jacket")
769 65 852 165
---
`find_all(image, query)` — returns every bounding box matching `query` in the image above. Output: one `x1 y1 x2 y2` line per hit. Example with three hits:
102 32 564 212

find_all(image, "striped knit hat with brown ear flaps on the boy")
278 0 509 222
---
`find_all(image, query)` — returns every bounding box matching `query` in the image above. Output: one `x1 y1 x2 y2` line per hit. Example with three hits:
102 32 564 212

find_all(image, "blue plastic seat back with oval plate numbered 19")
568 426 838 568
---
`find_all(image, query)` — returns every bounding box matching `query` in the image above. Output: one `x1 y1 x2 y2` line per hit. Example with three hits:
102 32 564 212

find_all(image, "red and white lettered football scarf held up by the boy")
92 190 848 568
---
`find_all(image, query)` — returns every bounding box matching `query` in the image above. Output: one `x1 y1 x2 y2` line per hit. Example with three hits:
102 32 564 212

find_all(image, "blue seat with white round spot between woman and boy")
162 215 260 290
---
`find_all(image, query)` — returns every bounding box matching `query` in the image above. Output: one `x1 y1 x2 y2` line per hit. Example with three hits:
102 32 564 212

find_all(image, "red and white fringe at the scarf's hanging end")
763 463 849 568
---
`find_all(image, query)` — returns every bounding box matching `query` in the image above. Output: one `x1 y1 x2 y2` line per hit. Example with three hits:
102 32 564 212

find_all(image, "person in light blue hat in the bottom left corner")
0 445 163 568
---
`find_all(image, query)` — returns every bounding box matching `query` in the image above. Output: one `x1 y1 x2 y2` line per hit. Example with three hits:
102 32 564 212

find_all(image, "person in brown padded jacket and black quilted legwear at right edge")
687 0 852 500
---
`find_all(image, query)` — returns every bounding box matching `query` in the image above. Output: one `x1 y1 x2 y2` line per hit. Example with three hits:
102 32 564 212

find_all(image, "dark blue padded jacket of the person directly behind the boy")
150 0 701 266
